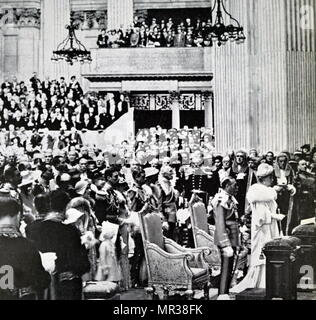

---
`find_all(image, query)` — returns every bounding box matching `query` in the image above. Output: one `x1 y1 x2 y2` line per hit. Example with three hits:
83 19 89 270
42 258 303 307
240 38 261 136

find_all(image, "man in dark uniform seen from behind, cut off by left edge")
0 190 50 300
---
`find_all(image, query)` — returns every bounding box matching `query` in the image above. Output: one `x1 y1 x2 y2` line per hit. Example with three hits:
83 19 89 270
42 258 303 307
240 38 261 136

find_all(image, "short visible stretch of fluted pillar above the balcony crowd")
107 0 134 29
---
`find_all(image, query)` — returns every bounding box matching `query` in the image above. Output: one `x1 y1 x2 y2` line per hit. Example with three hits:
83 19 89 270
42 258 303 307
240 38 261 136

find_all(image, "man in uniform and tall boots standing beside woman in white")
212 177 239 300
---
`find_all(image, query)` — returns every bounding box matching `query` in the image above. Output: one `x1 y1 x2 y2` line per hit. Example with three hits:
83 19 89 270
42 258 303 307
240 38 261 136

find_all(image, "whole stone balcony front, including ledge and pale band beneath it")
82 47 213 91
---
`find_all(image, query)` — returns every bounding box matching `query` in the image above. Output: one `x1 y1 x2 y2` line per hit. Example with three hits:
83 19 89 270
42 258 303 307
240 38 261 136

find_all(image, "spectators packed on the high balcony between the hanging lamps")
97 17 215 48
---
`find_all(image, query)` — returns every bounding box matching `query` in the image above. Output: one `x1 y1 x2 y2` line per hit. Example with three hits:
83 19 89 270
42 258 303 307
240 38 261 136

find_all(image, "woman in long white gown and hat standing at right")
231 163 284 293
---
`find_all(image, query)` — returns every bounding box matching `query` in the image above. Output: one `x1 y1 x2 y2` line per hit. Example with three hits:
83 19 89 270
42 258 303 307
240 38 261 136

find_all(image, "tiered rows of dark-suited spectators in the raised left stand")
0 73 128 130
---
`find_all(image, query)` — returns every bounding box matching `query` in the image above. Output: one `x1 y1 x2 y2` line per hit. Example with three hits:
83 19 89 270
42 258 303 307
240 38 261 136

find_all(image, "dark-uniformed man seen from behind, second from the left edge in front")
25 190 90 300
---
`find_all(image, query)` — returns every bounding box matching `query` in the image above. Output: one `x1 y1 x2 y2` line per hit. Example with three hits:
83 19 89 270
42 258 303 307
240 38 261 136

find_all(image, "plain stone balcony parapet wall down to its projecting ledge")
82 47 213 81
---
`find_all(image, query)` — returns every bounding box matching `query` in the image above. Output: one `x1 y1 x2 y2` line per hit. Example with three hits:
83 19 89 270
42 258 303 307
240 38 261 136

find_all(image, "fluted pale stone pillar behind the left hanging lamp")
40 0 70 79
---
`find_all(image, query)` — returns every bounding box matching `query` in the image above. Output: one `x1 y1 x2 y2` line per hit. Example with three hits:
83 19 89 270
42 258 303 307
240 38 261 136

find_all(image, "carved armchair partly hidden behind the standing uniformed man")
189 201 221 269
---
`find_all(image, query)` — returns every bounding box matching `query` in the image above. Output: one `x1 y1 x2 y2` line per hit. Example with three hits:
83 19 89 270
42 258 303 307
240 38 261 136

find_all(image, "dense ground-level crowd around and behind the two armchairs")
0 115 316 299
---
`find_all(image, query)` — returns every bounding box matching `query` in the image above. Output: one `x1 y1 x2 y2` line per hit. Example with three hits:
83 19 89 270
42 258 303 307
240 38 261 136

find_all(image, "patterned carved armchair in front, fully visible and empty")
139 213 210 299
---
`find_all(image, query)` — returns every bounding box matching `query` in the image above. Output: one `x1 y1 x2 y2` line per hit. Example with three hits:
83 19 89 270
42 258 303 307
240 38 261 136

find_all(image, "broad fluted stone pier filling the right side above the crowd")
212 0 316 153
